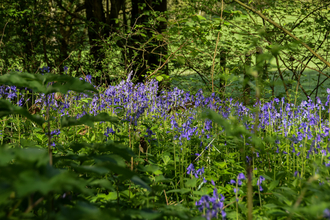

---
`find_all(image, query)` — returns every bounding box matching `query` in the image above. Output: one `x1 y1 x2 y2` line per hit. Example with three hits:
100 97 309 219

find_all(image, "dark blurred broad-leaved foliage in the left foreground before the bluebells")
0 72 199 219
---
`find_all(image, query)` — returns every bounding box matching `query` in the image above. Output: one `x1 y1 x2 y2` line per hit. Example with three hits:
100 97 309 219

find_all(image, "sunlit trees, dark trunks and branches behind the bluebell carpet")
0 0 329 104
